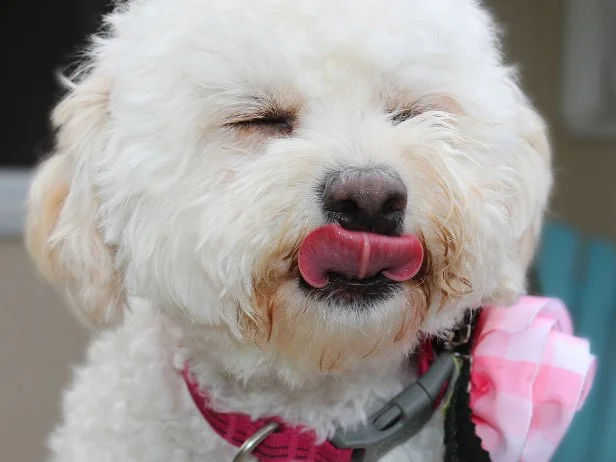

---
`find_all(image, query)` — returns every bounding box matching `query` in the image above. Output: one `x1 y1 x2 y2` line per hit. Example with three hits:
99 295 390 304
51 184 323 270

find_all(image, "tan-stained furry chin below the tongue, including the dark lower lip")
241 271 428 376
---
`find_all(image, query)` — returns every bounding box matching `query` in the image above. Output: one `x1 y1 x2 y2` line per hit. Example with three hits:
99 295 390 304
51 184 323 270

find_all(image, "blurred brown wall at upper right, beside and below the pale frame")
488 0 616 238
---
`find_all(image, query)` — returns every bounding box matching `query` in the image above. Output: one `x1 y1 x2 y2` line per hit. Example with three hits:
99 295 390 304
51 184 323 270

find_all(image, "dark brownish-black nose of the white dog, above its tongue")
323 169 407 235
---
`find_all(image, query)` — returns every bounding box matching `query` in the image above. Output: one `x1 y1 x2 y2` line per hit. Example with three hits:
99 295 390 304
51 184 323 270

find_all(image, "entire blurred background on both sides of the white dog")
0 0 616 462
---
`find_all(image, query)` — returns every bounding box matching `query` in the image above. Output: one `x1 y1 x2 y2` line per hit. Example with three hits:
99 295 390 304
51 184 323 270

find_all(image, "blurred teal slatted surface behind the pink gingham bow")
532 222 616 462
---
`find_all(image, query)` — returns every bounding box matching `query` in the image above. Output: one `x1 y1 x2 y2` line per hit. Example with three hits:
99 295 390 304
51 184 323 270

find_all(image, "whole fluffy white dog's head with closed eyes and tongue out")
28 0 551 371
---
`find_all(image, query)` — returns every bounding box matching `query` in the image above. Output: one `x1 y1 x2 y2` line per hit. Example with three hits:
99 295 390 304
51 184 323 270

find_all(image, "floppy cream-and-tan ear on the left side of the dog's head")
26 75 124 327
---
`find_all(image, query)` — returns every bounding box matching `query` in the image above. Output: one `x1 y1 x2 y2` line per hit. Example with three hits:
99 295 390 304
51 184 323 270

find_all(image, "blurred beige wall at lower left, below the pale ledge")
0 241 86 462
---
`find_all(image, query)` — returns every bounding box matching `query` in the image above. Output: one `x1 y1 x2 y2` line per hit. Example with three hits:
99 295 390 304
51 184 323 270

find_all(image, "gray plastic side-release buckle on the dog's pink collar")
331 352 456 462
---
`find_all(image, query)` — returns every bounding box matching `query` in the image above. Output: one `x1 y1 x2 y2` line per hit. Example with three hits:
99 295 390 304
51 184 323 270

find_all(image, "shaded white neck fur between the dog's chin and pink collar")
174 312 414 438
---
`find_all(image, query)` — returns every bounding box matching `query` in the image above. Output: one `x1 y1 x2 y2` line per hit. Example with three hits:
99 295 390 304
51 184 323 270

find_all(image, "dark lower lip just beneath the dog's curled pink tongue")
298 273 402 310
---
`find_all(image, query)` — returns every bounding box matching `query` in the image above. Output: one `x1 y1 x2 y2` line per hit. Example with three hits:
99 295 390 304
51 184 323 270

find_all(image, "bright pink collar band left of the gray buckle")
182 367 353 462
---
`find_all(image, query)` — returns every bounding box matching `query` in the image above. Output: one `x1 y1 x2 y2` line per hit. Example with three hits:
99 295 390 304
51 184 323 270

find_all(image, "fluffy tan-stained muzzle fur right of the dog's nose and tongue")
403 143 494 313
